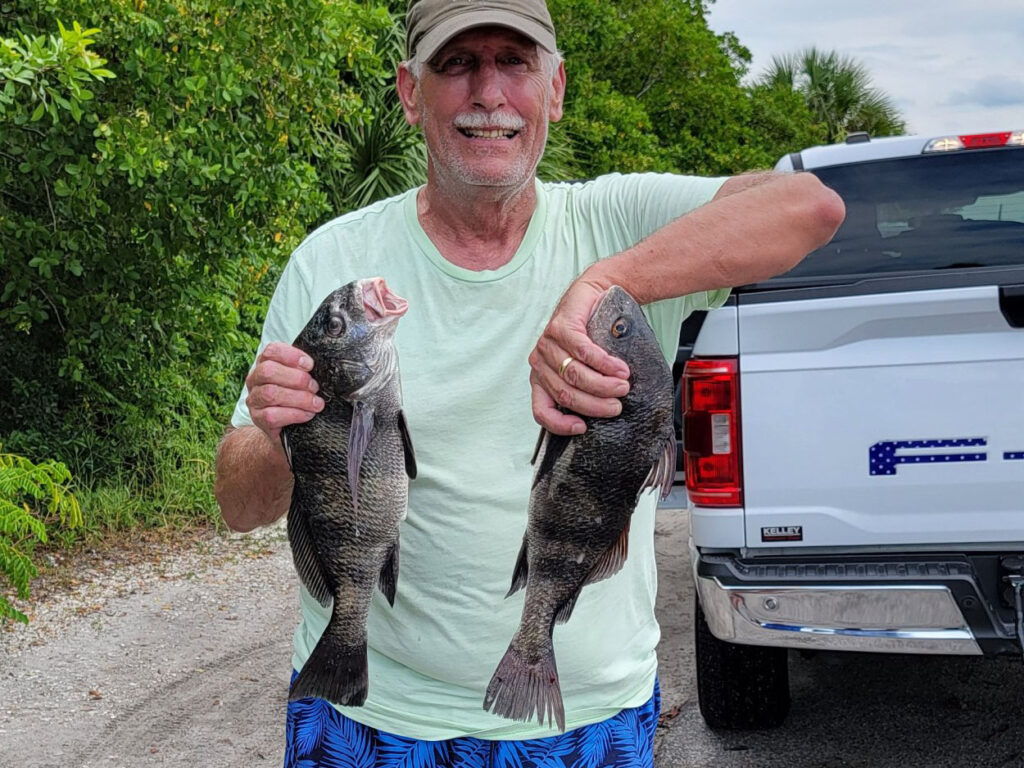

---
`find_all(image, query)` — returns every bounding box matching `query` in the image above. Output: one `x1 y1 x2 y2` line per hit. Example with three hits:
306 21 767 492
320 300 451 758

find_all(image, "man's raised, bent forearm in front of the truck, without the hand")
582 174 845 304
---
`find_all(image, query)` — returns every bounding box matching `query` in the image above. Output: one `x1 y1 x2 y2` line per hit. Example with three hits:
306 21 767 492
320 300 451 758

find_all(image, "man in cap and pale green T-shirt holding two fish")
216 0 844 766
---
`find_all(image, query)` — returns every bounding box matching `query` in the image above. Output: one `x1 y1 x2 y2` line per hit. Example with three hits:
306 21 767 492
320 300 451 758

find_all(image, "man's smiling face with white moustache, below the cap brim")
398 27 565 193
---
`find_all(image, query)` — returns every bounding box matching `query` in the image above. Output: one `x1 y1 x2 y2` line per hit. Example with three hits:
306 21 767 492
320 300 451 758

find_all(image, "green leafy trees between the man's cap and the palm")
549 0 817 176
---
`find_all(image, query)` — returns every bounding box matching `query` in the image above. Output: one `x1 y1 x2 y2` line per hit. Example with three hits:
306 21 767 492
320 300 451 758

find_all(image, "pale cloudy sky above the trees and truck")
707 0 1024 135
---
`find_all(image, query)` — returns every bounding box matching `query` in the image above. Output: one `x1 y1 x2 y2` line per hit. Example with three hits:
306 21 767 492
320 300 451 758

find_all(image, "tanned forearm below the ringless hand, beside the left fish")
214 427 294 531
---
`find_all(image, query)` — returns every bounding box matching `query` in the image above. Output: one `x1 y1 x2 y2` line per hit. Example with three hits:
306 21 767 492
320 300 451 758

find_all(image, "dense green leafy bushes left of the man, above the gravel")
0 0 391 518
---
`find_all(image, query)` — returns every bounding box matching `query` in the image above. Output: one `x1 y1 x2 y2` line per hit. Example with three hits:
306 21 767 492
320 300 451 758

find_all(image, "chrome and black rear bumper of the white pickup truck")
690 541 995 655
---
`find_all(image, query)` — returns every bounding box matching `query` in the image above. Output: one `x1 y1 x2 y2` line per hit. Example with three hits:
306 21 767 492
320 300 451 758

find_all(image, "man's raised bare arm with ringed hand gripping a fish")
529 173 846 434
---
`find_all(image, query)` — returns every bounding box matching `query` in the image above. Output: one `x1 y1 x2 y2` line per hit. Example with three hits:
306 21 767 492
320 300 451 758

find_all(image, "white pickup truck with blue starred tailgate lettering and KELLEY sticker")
682 132 1024 728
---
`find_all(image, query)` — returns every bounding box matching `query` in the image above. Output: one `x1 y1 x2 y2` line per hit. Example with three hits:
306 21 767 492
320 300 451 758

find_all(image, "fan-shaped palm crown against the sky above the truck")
759 47 906 143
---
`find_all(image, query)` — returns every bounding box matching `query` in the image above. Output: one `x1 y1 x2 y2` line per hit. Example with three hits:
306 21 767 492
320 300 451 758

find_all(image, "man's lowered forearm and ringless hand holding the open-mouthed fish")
214 343 324 531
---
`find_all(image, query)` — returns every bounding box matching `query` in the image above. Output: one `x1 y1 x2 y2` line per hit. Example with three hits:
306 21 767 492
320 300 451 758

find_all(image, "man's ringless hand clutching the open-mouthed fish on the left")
246 342 324 446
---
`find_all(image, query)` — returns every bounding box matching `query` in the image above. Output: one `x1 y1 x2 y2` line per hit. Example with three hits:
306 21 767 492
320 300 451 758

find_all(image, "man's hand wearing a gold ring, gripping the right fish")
529 274 630 435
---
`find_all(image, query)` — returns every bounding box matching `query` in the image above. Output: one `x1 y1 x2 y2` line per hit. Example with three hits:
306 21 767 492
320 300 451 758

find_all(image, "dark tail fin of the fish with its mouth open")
288 617 369 707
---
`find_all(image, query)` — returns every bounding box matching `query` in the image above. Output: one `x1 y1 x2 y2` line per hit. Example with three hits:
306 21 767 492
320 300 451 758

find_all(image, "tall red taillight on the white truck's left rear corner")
683 357 743 507
